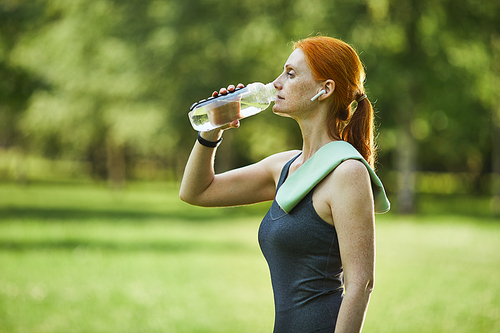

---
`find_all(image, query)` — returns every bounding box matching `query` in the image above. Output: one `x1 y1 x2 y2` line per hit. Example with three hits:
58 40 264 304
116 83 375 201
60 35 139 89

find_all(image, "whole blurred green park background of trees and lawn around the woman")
0 0 500 332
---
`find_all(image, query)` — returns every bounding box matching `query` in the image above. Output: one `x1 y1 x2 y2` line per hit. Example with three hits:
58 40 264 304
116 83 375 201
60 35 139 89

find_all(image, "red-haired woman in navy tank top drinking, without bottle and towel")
180 37 390 333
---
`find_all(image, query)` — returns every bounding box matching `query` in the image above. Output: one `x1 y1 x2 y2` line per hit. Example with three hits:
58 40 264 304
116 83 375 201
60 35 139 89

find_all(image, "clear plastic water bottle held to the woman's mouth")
188 82 276 132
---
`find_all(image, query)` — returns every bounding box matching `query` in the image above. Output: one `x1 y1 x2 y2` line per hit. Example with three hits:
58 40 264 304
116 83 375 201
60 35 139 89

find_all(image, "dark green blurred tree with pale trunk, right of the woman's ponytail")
351 0 498 213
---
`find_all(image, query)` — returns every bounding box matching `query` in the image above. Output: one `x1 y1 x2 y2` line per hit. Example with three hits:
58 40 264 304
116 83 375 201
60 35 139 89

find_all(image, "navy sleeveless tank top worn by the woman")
259 154 343 333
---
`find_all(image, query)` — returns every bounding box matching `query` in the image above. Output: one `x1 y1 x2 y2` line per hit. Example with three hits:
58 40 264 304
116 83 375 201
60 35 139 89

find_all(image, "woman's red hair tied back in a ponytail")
294 36 376 167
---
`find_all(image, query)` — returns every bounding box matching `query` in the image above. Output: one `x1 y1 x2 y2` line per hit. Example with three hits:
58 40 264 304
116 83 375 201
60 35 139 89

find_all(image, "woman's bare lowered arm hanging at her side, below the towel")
331 160 375 333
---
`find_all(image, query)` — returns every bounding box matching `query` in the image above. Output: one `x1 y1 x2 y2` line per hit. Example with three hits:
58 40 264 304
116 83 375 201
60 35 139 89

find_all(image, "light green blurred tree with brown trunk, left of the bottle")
13 1 175 185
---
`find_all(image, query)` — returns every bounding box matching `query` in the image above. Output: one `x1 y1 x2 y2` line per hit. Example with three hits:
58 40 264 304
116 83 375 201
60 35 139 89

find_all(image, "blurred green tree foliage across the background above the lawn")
0 0 500 200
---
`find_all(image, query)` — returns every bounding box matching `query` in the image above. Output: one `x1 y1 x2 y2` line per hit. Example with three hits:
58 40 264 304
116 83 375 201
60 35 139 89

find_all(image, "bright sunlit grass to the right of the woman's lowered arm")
365 217 500 333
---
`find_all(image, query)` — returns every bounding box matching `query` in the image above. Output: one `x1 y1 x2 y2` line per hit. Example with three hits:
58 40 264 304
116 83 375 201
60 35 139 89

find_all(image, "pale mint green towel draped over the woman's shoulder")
276 141 391 213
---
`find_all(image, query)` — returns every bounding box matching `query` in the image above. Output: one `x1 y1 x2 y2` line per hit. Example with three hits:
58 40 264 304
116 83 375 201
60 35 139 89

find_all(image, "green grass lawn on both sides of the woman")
0 184 500 333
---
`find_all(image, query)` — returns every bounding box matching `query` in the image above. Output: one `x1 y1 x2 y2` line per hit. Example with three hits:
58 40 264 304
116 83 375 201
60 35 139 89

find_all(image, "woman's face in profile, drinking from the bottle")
273 49 321 117
